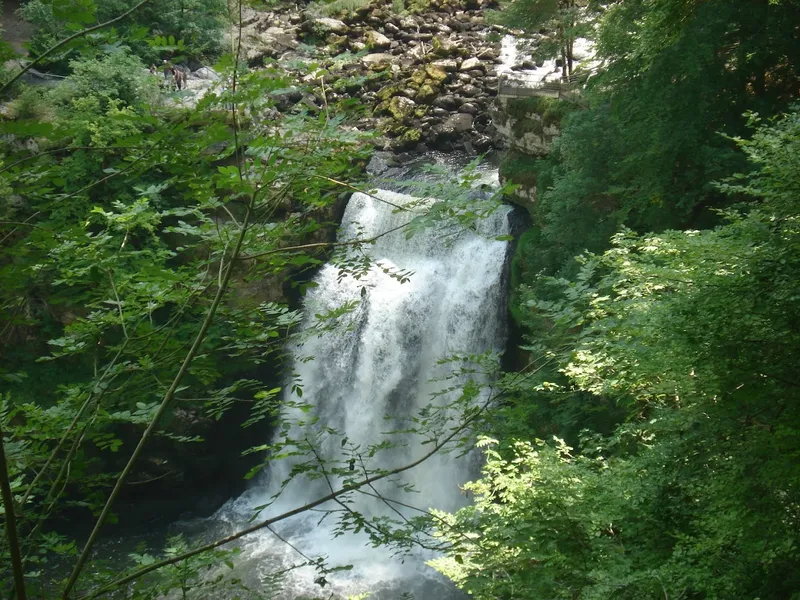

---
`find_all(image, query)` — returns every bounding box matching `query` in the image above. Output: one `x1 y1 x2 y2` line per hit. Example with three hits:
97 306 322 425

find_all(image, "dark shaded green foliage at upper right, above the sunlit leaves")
509 1 798 324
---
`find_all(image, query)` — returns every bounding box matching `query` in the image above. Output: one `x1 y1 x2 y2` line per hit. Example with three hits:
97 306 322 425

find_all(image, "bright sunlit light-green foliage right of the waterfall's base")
434 111 800 599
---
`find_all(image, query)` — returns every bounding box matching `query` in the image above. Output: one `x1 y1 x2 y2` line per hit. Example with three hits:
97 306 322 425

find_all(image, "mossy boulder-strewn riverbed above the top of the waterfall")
222 0 503 152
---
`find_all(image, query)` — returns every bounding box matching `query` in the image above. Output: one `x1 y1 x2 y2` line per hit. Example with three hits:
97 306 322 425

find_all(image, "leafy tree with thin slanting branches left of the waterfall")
0 3 512 598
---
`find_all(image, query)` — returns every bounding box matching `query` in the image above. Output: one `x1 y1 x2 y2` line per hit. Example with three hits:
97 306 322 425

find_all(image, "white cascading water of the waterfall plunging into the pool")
218 185 510 600
